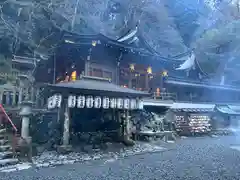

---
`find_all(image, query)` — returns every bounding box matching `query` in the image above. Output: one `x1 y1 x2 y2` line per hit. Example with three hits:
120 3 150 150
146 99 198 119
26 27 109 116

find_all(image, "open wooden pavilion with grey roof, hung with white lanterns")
46 77 148 150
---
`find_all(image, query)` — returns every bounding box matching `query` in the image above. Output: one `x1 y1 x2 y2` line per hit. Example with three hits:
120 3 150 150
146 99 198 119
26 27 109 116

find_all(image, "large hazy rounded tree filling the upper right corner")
192 1 240 83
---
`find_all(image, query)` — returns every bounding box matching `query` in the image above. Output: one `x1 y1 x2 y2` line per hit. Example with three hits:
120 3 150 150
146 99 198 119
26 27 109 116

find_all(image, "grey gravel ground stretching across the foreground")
0 136 240 180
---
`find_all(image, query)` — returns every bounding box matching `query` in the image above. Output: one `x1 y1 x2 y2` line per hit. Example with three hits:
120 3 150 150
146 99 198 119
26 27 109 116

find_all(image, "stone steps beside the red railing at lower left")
0 124 19 168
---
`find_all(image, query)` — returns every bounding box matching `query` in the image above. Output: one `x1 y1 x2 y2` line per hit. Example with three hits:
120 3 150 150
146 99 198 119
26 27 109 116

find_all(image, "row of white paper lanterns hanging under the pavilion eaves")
48 94 143 109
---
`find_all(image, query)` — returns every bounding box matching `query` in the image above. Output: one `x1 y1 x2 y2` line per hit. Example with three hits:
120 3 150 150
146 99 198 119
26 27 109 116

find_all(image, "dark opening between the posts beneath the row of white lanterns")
70 108 123 148
